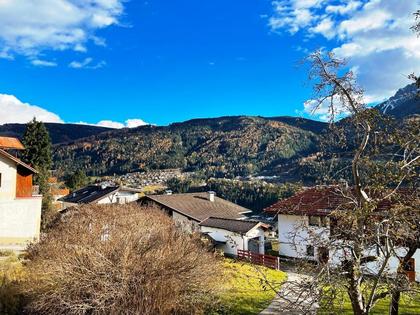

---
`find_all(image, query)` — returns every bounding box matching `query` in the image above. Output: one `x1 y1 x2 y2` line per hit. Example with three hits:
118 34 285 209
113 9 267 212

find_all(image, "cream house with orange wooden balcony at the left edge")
0 137 42 249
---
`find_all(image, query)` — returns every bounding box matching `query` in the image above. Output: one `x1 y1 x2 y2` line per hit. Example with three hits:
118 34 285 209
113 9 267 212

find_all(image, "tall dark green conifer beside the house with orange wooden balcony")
22 118 52 228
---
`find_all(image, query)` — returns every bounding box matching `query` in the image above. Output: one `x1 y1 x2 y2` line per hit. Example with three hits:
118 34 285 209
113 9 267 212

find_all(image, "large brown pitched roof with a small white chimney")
143 192 252 222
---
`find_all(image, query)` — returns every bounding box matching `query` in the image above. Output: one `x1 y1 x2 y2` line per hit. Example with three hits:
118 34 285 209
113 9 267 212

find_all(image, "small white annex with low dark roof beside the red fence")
200 217 268 256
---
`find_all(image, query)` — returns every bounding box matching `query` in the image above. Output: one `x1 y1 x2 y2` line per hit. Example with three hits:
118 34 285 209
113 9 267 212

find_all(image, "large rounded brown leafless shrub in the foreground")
26 205 219 314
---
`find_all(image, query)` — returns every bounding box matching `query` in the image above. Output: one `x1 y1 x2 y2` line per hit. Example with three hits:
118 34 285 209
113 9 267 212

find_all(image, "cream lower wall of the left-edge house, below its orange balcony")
0 197 42 246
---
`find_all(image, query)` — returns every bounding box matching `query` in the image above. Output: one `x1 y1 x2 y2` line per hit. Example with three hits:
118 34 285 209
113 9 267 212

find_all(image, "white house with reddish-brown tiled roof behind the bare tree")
264 186 420 281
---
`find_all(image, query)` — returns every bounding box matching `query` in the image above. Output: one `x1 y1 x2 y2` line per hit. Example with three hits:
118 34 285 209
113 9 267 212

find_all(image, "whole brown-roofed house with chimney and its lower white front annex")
140 191 270 256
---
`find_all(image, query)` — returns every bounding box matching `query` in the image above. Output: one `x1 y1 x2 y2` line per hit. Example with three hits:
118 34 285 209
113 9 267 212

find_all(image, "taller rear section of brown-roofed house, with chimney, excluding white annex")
140 191 252 232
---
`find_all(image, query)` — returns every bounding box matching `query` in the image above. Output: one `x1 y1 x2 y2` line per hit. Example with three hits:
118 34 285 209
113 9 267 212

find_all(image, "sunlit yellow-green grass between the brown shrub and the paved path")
221 260 286 315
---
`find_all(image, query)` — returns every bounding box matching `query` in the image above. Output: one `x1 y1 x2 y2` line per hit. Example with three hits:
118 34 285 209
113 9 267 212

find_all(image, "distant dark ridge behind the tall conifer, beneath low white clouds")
0 123 114 144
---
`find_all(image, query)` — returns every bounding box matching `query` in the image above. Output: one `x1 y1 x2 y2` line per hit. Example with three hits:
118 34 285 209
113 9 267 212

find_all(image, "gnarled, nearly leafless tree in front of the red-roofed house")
270 50 420 315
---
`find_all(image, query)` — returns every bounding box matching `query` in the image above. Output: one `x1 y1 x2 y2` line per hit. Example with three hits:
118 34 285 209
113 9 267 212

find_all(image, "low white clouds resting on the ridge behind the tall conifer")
0 94 148 129
